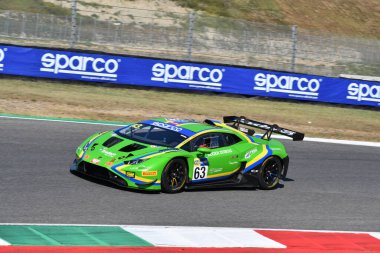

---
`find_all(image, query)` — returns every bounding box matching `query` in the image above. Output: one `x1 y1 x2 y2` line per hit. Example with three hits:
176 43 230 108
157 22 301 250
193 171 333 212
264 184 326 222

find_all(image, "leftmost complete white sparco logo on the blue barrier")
40 53 120 78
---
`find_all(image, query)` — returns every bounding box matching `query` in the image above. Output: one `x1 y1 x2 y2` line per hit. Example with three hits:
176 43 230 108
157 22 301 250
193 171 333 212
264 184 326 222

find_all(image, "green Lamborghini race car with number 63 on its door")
70 116 304 193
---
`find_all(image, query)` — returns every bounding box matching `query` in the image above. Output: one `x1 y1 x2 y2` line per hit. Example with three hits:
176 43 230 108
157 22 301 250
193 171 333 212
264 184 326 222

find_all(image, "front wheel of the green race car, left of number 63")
161 158 187 193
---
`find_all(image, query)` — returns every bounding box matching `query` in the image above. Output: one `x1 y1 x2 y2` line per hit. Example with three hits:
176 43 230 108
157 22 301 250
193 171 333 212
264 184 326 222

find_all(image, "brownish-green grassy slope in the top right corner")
173 0 380 39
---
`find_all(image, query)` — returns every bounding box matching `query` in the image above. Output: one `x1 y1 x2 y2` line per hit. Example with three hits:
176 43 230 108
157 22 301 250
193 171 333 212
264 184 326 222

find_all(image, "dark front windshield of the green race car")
116 124 186 147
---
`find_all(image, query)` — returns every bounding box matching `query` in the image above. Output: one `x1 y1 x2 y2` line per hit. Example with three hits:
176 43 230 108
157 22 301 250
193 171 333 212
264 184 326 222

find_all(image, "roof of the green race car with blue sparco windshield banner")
139 118 222 137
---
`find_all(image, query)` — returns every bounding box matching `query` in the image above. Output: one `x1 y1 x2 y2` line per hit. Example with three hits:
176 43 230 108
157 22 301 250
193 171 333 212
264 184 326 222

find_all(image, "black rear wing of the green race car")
223 116 305 141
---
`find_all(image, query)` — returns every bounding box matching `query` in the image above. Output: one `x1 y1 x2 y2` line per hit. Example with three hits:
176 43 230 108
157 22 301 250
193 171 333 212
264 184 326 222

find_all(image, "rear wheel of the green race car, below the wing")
259 156 282 190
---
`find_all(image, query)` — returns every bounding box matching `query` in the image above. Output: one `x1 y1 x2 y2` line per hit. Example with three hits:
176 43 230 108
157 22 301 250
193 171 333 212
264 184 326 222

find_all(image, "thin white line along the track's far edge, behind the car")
0 115 380 147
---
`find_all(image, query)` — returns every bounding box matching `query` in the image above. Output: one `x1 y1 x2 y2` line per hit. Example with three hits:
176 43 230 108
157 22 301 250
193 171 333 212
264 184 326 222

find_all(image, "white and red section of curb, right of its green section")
121 226 380 250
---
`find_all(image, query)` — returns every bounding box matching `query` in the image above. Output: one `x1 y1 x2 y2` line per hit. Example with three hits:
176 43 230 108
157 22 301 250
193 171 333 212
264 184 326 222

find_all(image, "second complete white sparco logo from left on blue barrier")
151 63 225 90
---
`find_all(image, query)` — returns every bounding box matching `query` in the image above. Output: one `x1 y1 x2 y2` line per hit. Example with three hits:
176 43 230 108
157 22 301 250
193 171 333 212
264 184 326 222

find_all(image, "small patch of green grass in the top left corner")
0 0 71 16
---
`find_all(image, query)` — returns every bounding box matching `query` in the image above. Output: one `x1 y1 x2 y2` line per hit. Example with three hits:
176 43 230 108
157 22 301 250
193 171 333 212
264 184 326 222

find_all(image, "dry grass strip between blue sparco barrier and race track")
0 78 380 141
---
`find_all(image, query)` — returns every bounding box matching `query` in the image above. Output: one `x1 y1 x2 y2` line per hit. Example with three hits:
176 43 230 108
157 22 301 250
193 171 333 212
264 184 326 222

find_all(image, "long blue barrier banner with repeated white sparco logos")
0 45 380 107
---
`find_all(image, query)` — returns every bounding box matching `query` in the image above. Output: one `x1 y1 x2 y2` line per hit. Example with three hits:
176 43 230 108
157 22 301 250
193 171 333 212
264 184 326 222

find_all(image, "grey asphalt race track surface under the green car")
0 118 380 232
